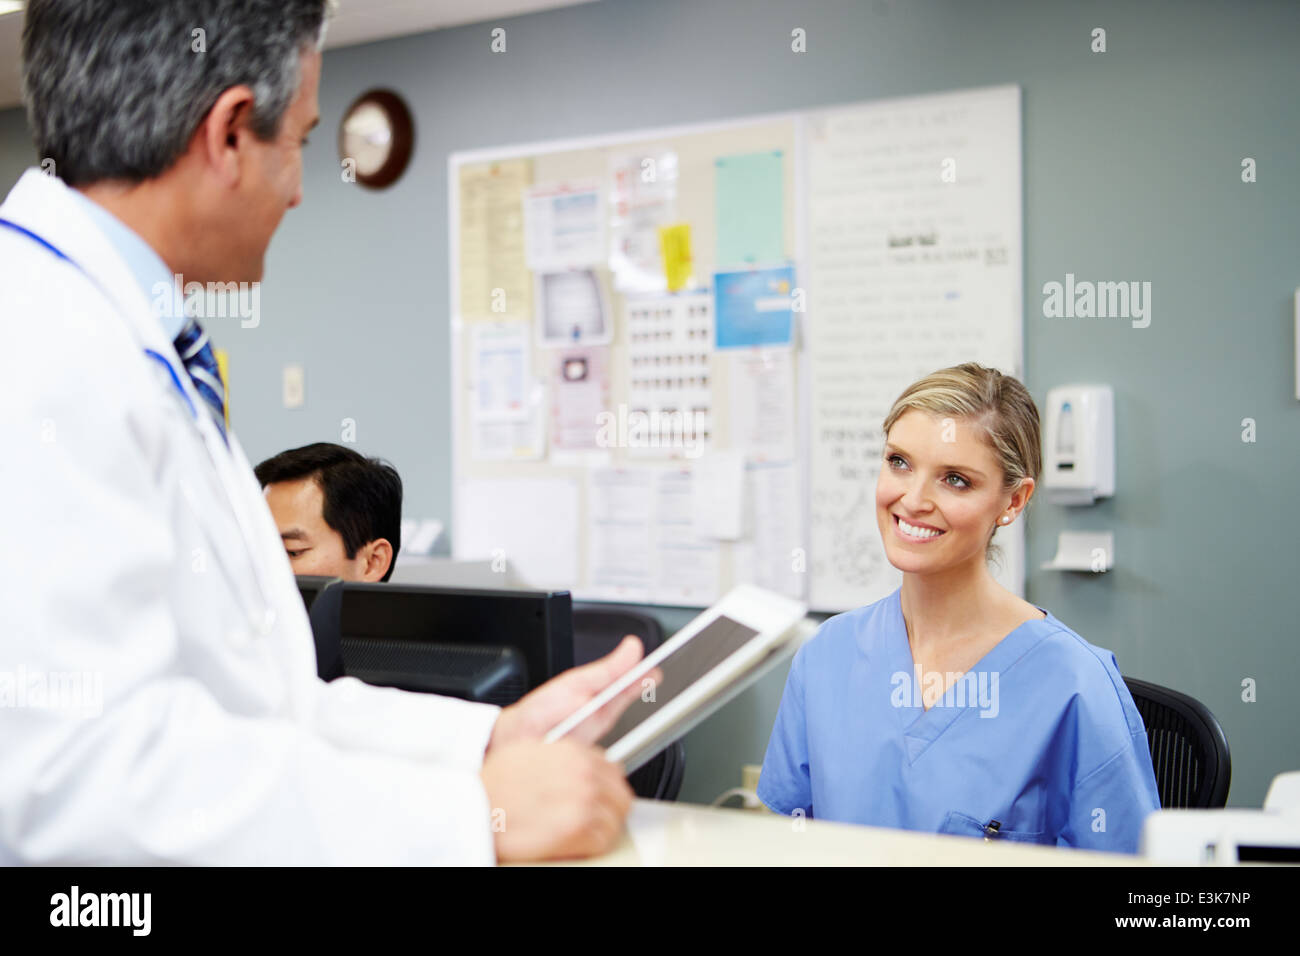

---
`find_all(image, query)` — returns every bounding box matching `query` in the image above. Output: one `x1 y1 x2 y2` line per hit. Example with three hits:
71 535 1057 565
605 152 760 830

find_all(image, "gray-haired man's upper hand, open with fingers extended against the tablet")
488 635 663 753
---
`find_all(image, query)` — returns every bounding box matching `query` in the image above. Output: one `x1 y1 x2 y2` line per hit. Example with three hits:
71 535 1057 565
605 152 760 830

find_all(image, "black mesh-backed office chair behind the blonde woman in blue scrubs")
1125 678 1232 809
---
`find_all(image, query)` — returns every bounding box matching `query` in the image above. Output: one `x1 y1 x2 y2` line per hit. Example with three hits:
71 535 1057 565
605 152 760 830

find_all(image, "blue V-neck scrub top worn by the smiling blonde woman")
758 589 1160 853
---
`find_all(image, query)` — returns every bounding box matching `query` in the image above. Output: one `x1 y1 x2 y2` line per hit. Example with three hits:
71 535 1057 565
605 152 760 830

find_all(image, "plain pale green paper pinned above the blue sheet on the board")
714 150 785 269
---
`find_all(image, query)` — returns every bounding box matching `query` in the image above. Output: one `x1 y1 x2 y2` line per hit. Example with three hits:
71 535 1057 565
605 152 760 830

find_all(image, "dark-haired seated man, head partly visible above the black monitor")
254 442 402 581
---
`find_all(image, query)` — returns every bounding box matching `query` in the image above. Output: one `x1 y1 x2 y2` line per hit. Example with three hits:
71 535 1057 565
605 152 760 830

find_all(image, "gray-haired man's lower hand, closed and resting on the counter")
480 739 632 862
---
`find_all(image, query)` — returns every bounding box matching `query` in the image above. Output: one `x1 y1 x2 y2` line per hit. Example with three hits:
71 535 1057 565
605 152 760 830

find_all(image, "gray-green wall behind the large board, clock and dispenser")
0 0 1300 806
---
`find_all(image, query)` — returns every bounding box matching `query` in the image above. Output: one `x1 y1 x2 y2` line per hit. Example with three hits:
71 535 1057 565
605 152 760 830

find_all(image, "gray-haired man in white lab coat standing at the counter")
0 0 641 864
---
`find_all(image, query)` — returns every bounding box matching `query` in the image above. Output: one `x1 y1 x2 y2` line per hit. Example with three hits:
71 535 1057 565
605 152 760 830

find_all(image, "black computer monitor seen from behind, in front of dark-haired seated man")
311 583 573 705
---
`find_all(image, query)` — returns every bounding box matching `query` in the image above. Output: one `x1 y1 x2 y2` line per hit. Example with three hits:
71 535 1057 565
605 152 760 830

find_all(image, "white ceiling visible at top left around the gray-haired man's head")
0 0 603 109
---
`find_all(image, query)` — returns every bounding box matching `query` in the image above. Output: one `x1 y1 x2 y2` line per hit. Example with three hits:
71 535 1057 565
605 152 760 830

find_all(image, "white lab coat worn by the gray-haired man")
0 169 498 864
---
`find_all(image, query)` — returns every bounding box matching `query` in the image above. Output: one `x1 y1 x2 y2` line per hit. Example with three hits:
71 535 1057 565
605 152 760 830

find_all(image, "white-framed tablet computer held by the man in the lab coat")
546 585 810 773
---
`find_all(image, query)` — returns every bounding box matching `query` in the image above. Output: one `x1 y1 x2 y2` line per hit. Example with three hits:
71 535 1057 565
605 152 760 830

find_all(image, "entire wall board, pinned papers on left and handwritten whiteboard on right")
449 86 1023 611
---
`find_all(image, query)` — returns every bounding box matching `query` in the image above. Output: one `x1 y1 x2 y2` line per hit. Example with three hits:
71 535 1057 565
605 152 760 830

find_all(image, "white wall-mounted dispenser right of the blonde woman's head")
1043 385 1115 505
